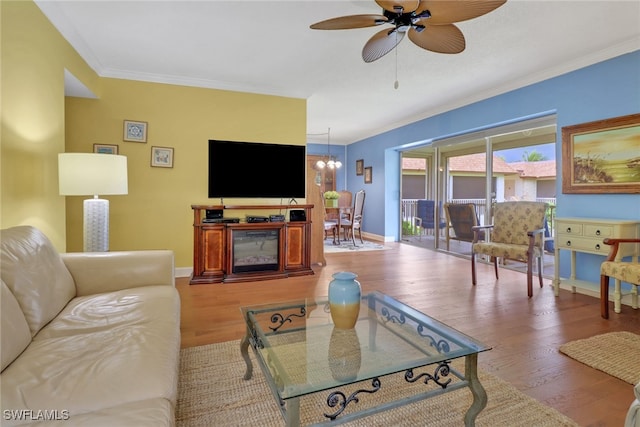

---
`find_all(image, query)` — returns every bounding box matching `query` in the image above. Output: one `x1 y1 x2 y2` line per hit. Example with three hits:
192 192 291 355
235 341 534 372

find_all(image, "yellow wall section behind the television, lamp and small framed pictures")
66 79 306 267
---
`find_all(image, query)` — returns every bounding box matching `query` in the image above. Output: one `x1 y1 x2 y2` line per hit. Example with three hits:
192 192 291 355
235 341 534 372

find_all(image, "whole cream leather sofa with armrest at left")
0 226 180 427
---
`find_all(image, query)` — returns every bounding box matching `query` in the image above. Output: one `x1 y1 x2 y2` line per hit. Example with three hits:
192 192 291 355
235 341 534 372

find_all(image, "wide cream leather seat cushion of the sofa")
0 286 180 425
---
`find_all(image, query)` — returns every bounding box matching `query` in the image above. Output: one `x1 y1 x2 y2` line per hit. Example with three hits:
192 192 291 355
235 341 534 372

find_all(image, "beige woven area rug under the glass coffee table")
176 341 577 427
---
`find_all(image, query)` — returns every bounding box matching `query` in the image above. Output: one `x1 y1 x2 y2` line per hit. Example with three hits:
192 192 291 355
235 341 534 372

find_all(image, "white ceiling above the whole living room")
36 0 640 144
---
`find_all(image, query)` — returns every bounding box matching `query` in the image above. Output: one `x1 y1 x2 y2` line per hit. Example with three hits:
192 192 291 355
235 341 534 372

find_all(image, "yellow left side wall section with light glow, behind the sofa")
0 1 99 251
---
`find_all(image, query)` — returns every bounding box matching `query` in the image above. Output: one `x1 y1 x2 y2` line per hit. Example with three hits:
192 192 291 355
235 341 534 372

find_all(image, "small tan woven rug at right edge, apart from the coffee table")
560 332 640 385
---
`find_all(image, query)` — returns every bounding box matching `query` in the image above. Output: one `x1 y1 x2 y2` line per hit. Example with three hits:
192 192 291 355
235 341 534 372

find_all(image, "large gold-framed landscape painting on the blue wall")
562 114 640 194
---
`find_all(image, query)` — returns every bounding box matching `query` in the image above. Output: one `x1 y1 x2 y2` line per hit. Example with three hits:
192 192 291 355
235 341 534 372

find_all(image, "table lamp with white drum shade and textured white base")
58 153 128 252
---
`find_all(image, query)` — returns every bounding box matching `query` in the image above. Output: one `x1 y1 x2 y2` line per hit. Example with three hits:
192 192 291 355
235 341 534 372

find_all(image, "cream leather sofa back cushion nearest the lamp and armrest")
0 226 76 336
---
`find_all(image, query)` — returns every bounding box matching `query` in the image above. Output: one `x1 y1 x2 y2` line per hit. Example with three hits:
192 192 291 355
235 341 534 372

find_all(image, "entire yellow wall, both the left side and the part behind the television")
0 0 306 267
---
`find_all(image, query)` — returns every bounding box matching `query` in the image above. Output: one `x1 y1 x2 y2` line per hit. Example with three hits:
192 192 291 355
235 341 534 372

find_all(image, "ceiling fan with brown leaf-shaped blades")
311 0 507 62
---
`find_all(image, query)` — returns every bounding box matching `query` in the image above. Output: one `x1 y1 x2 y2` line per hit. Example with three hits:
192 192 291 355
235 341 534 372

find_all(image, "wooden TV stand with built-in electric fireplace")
190 205 314 285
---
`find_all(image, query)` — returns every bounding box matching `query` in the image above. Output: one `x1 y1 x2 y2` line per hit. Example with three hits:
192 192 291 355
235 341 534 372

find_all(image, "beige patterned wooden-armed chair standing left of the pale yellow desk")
471 202 547 298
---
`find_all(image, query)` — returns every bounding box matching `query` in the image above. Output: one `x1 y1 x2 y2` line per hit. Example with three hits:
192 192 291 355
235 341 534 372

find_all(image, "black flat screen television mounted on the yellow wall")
209 139 306 199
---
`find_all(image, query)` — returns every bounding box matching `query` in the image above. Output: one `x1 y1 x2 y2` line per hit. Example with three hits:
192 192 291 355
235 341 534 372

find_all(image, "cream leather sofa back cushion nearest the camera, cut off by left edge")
0 281 31 371
